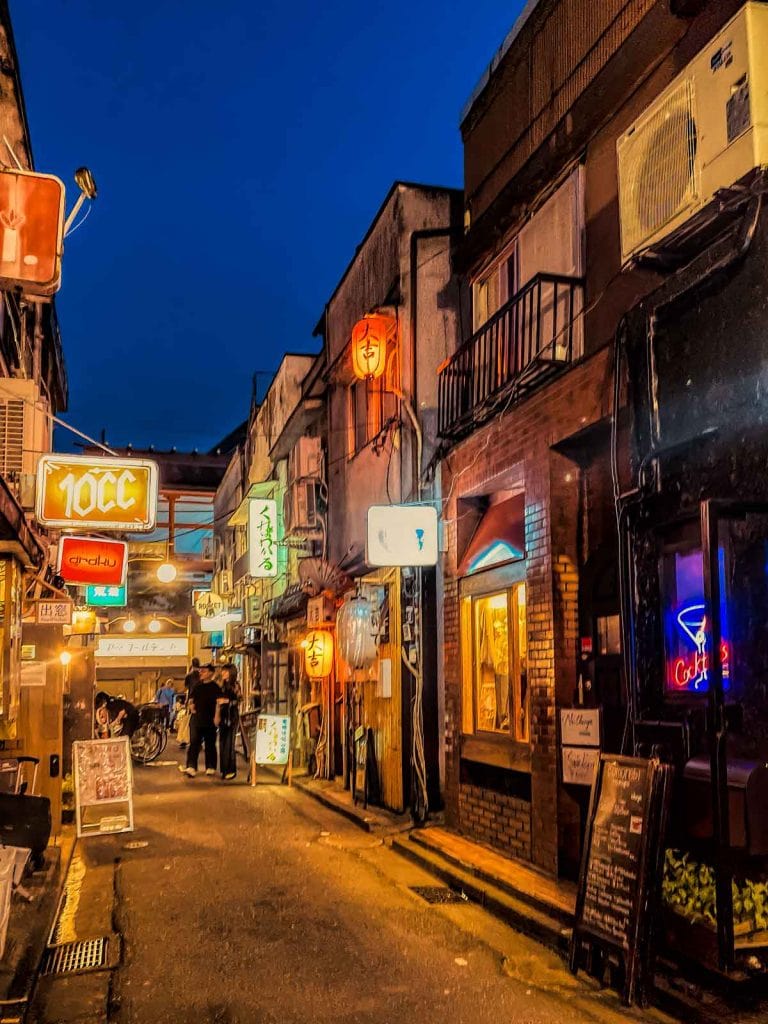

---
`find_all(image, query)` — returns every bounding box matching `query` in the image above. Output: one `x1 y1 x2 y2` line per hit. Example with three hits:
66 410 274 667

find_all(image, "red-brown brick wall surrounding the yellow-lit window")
441 349 611 874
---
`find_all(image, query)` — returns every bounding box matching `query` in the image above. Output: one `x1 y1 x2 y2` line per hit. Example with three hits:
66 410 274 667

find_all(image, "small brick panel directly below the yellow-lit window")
458 783 530 860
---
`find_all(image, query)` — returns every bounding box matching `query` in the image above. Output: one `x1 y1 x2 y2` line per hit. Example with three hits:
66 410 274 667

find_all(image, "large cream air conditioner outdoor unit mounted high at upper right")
616 2 768 263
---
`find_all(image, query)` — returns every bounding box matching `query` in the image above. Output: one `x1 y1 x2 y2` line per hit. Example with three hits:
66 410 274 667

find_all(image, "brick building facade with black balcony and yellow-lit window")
438 0 742 877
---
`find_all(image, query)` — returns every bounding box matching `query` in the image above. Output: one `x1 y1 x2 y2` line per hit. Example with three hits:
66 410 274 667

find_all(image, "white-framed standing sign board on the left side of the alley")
72 736 133 838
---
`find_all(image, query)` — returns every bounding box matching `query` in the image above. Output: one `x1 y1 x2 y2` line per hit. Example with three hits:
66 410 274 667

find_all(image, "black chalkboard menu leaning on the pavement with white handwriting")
570 755 670 1006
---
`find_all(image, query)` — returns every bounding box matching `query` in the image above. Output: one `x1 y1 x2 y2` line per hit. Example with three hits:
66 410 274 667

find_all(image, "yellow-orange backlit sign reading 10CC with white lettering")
36 455 158 536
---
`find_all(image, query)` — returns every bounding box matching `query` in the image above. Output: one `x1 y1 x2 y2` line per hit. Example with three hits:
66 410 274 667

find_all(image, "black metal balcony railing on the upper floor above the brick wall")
438 273 584 440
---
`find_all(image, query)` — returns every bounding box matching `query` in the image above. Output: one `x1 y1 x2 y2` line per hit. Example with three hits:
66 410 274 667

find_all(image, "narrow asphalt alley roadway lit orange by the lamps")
32 762 662 1024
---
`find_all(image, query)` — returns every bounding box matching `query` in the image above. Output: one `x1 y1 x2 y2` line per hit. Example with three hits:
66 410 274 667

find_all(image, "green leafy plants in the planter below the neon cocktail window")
662 850 768 930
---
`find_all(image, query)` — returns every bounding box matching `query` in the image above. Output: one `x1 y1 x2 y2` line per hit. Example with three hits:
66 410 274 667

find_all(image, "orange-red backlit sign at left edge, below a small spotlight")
0 169 65 295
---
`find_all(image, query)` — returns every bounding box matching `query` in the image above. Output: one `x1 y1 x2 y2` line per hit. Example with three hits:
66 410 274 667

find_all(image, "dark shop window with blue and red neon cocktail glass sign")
664 548 731 693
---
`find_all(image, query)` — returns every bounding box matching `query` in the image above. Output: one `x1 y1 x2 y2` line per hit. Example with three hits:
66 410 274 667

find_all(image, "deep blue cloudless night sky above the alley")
11 0 521 449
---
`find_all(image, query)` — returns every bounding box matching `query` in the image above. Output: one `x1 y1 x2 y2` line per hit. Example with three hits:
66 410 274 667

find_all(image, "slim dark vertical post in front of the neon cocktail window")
701 501 733 971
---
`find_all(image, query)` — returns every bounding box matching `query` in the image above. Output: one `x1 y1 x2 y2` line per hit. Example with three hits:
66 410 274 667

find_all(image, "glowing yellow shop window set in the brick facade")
462 584 529 741
